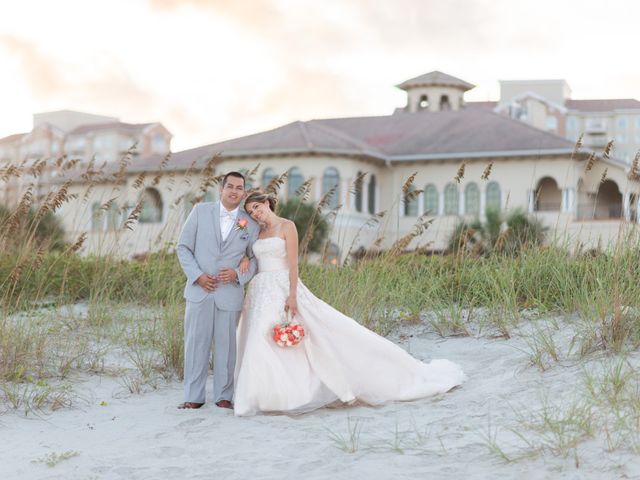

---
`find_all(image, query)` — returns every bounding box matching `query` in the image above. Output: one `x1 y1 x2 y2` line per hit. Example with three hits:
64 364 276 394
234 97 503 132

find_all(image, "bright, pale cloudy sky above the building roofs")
0 0 640 151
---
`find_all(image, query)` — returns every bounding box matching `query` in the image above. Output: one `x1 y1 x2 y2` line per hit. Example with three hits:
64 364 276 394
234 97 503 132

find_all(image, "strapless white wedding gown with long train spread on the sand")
234 237 465 415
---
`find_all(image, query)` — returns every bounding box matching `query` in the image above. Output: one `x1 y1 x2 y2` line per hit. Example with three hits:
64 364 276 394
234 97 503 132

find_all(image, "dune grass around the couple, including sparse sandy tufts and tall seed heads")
0 140 640 468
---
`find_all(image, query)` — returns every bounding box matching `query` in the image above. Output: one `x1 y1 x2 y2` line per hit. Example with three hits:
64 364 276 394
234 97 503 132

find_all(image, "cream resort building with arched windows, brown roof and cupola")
0 72 640 256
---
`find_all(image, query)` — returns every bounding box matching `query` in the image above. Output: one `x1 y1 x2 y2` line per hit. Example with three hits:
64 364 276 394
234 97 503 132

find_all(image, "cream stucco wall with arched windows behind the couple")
57 156 639 256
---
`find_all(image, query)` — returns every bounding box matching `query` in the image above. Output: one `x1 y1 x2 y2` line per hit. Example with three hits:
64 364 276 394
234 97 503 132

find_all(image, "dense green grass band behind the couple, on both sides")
0 247 640 342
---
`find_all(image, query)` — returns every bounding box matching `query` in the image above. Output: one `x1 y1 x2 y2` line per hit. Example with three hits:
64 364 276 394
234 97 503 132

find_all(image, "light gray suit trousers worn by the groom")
184 295 240 403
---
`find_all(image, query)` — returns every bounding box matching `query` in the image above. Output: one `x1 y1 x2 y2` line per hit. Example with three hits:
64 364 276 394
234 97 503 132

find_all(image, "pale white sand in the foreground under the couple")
0 314 640 480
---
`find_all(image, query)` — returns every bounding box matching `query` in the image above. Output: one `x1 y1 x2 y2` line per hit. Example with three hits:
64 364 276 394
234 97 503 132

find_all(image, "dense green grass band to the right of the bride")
302 247 640 340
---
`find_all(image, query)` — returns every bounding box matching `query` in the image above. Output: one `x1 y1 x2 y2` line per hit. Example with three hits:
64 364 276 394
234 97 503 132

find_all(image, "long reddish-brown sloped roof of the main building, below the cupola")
172 108 573 168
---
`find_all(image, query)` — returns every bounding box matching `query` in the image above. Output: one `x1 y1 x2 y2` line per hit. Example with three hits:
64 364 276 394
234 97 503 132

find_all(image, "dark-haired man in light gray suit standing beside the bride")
177 172 259 408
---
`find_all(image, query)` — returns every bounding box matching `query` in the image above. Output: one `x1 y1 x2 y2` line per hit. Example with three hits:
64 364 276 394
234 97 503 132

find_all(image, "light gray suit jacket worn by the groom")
177 202 260 311
